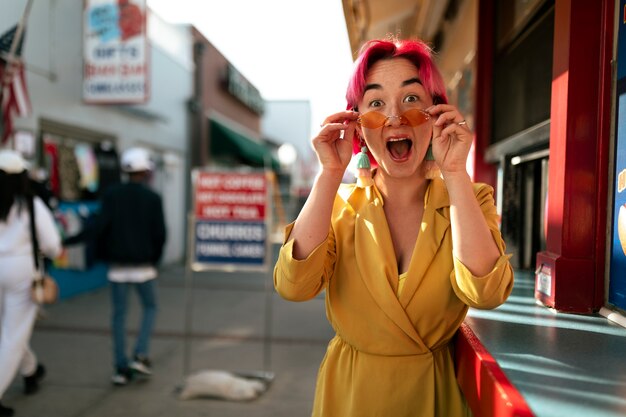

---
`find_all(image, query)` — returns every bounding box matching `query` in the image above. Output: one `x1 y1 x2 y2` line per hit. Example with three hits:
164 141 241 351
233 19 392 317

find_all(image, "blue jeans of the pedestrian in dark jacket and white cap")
110 279 157 369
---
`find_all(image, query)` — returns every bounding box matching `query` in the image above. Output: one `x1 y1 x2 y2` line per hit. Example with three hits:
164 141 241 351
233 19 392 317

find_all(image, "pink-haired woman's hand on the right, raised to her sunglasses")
426 104 473 177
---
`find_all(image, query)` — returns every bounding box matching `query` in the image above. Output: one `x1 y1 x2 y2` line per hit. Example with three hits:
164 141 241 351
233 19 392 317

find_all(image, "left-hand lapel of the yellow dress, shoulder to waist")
350 186 428 350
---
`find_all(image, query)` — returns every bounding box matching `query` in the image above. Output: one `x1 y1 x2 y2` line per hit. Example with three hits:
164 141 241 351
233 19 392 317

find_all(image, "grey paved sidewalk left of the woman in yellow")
3 266 333 417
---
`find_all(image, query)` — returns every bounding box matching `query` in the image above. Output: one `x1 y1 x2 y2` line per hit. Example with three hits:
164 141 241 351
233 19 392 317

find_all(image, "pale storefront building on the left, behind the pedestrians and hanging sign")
0 0 193 298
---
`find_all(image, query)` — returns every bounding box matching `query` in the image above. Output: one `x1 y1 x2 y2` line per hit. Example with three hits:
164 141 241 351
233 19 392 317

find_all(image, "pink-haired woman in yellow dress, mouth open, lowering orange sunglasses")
274 39 513 417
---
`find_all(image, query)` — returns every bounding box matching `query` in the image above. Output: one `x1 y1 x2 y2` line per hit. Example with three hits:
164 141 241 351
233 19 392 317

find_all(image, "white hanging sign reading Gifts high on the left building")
83 0 150 103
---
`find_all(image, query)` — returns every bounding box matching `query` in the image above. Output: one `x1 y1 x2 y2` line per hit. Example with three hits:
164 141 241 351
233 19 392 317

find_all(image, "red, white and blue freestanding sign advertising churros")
192 171 268 269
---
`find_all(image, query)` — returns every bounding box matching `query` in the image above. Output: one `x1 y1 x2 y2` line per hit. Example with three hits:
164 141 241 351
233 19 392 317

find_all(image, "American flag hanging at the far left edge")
0 25 31 143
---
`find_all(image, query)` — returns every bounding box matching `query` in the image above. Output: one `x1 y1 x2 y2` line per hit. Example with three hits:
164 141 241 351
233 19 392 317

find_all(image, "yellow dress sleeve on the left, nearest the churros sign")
274 223 335 301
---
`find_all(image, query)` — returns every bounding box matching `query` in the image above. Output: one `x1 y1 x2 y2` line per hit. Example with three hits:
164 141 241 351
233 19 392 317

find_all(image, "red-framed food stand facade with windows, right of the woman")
343 0 626 313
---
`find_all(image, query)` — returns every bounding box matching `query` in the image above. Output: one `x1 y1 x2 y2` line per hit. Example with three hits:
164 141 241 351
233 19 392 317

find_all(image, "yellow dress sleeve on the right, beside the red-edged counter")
450 184 513 309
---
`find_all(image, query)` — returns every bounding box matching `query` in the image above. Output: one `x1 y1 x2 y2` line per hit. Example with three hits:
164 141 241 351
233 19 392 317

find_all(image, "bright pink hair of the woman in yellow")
346 39 448 161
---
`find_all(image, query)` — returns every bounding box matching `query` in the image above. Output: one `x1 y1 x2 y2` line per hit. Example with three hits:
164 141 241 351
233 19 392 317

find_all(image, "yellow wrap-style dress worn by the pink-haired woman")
274 178 513 417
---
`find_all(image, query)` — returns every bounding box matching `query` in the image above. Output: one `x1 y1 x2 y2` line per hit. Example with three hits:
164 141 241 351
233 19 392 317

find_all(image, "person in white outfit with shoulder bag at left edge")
0 150 61 417
